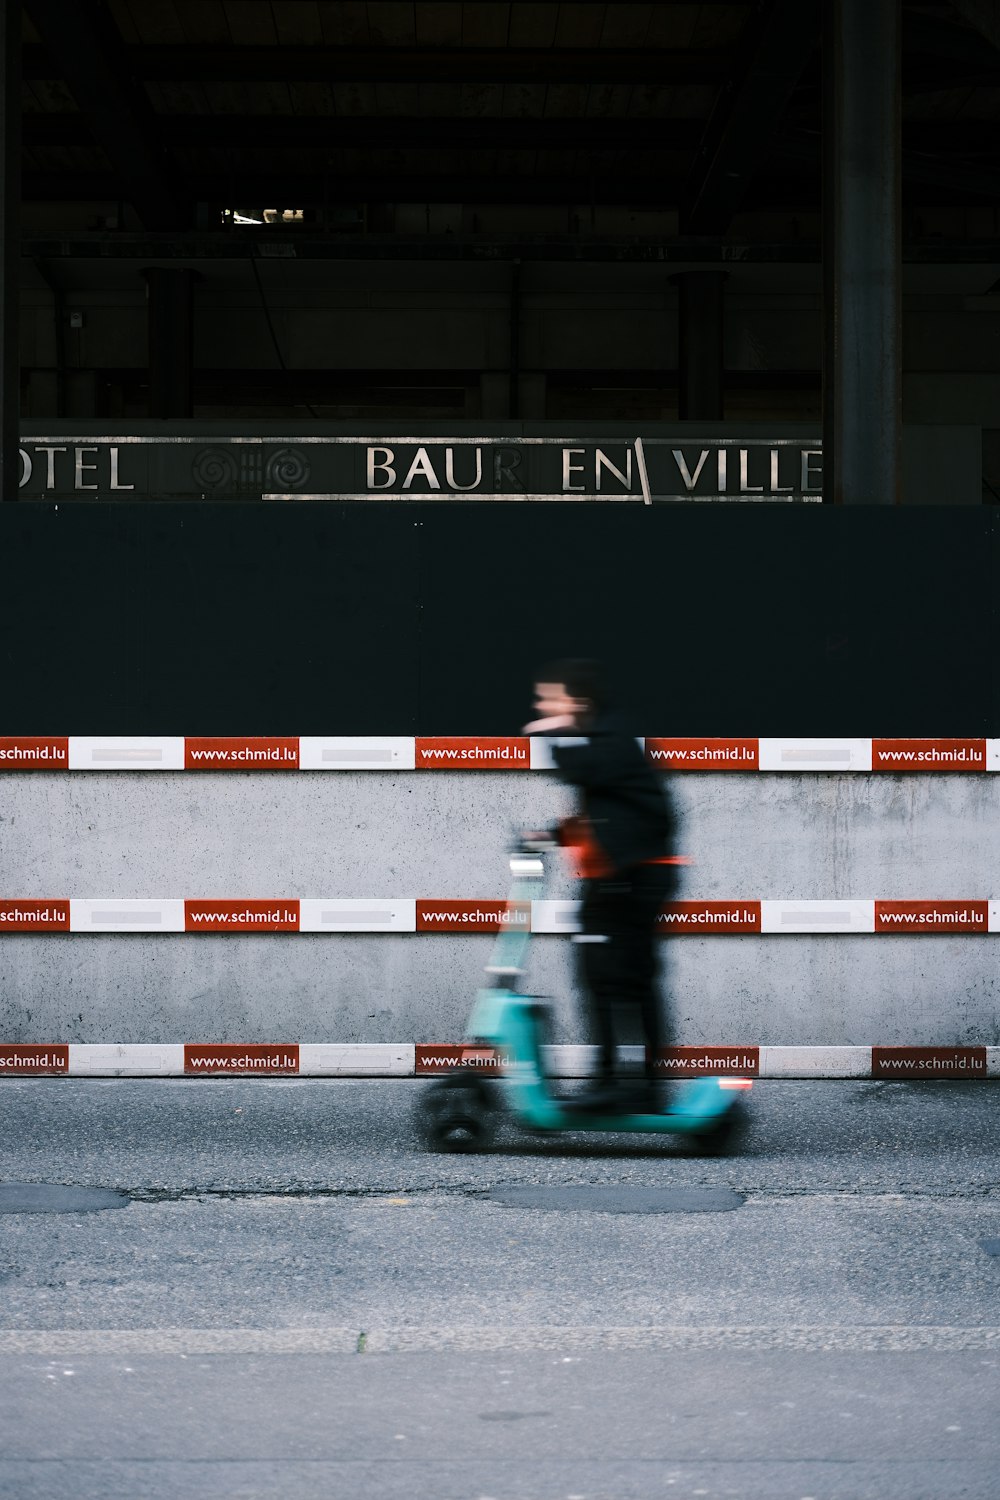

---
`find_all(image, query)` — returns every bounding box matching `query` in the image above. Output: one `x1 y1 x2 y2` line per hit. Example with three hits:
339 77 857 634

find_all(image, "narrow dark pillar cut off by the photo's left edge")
0 0 21 501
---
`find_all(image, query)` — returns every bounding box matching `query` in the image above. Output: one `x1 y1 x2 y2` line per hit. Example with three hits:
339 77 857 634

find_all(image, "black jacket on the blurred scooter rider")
550 716 676 870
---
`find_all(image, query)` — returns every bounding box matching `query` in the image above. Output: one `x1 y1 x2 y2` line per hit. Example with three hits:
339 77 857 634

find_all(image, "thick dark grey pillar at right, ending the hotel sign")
823 0 903 506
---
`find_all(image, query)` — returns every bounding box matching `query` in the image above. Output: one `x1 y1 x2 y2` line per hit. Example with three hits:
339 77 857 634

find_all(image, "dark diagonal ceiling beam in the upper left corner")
25 0 190 230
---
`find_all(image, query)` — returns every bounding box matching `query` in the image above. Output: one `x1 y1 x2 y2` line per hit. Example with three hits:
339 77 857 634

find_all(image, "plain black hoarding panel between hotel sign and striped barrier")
0 501 1000 737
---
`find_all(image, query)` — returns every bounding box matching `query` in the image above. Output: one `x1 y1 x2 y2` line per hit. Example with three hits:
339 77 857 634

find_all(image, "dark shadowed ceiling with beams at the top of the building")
22 0 1000 239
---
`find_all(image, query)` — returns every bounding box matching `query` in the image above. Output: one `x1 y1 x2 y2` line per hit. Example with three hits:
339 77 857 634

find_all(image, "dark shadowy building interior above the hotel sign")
6 0 1000 503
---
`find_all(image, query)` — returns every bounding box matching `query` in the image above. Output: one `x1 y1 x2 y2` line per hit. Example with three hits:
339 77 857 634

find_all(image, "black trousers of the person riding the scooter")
577 864 678 1082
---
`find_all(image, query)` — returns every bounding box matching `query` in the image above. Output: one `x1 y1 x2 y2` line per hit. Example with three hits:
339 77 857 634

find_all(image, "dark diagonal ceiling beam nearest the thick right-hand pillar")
681 0 822 234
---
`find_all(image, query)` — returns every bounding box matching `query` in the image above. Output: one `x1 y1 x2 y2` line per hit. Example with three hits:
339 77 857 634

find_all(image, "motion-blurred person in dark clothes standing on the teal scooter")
523 659 682 1113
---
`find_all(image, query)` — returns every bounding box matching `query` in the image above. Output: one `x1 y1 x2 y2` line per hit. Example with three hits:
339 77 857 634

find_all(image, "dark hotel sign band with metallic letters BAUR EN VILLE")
19 434 823 506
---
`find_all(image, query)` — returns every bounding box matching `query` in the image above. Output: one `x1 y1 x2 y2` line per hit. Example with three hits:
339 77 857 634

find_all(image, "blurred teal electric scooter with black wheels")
417 843 753 1155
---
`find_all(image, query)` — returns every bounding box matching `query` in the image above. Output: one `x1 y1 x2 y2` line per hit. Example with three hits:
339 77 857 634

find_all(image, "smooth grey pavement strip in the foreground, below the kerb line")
0 1352 997 1500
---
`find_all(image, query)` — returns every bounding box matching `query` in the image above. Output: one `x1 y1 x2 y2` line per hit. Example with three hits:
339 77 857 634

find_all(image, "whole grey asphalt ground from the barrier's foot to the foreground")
0 1079 1000 1500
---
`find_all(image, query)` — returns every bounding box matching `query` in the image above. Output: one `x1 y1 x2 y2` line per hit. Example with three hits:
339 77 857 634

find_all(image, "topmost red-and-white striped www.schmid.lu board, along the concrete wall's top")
0 735 1000 774
